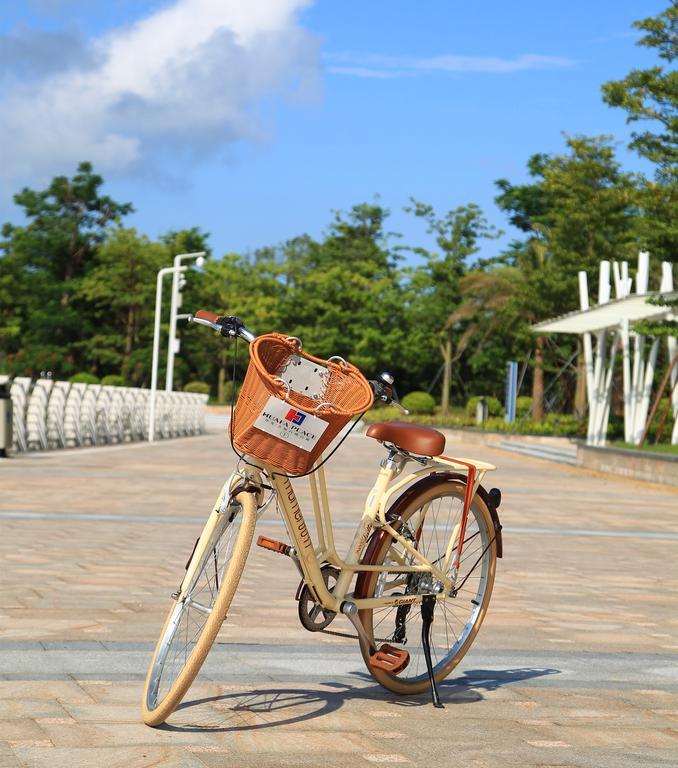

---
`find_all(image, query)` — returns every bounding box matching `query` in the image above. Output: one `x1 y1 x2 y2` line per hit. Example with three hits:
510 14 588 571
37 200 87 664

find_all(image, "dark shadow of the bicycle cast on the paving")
159 667 560 733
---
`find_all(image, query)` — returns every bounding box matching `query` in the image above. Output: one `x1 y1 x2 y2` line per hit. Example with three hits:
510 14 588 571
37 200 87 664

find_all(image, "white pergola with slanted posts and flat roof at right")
532 251 678 445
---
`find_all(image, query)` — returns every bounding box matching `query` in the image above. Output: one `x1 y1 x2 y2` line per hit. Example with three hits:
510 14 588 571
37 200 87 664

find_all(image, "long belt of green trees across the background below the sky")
0 4 678 417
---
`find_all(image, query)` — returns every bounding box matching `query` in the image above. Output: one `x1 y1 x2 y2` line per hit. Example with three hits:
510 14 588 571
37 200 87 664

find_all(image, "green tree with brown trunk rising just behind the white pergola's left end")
496 136 642 419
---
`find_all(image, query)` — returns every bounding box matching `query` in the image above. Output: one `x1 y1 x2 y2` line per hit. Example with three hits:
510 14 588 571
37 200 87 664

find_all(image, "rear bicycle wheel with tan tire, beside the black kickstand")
355 477 497 694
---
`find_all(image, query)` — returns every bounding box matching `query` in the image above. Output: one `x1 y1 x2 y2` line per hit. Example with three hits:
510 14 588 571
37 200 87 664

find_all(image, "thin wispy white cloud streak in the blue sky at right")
326 53 575 78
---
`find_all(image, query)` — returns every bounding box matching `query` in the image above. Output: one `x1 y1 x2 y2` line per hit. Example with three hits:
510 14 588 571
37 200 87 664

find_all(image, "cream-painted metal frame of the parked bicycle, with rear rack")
243 454 496 613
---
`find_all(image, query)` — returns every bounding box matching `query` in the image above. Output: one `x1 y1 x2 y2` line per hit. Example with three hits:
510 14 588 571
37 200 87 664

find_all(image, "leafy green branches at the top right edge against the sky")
602 2 678 183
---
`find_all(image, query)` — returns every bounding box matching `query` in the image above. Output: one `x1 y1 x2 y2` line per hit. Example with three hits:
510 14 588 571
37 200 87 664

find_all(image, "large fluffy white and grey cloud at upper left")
0 0 319 189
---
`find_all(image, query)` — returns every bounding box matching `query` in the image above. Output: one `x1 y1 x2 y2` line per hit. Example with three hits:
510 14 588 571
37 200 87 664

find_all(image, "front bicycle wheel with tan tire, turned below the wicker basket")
141 492 257 726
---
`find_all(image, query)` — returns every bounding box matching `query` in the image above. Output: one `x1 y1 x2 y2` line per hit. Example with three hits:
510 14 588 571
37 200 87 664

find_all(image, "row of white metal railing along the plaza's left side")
10 376 207 452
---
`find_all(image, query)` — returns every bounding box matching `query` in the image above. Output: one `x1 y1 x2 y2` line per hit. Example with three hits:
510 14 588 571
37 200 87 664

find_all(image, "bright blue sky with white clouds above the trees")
0 0 667 264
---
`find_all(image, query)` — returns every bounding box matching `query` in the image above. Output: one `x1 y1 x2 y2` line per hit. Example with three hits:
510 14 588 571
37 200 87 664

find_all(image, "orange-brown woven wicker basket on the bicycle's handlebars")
233 333 373 475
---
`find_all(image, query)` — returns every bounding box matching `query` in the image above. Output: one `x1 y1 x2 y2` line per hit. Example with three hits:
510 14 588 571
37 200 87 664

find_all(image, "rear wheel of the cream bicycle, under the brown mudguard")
356 478 497 694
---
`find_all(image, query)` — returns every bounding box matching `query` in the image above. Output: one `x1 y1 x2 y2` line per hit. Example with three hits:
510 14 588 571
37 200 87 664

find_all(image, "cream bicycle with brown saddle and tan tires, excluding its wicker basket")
142 311 502 726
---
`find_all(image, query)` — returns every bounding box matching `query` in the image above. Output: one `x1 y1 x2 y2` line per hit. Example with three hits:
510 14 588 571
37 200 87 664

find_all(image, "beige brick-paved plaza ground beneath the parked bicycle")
0 426 678 768
